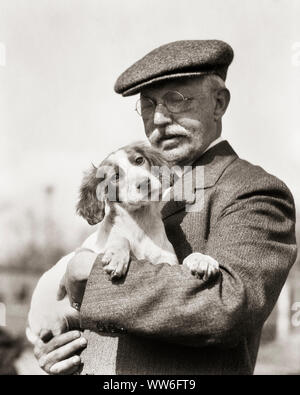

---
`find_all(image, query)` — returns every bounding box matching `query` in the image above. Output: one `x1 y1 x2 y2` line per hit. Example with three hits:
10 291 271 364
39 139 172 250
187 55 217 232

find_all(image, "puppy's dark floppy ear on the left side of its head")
77 165 105 225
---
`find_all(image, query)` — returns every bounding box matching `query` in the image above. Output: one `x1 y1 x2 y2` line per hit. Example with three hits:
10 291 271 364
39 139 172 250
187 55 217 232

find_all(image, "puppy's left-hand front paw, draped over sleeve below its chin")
102 240 130 280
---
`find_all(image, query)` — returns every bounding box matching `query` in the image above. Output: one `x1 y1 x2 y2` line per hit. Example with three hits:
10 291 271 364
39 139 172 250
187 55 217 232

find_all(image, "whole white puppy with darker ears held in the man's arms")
29 143 219 342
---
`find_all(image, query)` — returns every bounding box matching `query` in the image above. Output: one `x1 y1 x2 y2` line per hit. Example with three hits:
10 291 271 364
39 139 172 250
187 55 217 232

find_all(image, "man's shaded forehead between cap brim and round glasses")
141 76 205 97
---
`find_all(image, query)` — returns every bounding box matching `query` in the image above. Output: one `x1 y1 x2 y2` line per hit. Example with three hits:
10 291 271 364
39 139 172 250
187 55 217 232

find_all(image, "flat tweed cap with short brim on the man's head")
115 40 233 96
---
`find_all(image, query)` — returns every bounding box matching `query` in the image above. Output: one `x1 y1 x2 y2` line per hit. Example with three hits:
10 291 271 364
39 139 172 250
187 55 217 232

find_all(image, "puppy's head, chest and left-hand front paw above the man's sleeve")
77 143 178 277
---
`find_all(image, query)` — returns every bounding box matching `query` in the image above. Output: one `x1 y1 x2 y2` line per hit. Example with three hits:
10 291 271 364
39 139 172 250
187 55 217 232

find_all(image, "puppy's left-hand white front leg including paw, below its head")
102 229 130 279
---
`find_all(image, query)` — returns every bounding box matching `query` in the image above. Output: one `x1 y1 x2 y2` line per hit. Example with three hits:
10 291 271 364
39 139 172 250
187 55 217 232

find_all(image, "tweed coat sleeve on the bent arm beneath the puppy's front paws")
81 178 296 347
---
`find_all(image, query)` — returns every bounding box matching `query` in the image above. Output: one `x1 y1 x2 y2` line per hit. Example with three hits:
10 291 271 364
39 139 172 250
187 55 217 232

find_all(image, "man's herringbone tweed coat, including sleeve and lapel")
81 141 296 374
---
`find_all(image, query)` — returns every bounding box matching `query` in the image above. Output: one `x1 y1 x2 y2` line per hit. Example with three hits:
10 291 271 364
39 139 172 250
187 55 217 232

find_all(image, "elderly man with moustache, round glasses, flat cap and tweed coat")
35 40 296 374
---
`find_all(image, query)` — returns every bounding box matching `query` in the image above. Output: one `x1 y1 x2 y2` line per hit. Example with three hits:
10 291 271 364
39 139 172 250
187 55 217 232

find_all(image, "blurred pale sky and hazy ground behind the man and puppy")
0 0 300 374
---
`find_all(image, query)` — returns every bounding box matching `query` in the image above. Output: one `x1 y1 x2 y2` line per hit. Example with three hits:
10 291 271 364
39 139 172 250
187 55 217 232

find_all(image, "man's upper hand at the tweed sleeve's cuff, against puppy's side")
57 250 97 310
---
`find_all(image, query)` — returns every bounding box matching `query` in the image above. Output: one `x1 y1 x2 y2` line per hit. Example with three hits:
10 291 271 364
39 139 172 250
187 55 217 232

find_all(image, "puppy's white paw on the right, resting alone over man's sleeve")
183 252 220 281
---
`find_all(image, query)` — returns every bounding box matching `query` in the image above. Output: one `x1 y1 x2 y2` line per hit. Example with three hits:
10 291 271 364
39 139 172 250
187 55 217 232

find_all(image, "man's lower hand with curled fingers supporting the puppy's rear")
34 331 87 375
